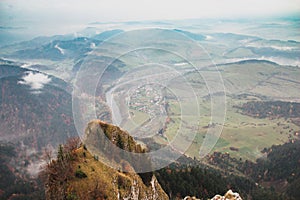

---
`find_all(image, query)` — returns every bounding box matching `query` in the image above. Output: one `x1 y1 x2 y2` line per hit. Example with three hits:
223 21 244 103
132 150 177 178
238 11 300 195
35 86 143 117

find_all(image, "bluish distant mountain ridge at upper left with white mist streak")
0 29 124 61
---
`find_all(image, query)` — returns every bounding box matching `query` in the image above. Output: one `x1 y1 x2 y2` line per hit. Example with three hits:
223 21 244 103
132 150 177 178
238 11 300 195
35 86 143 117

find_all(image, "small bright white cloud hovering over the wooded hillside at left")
18 72 51 90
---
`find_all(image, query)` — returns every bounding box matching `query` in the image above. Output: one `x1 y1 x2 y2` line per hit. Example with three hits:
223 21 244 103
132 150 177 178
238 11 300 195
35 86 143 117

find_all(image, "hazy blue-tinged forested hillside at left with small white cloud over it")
0 64 76 150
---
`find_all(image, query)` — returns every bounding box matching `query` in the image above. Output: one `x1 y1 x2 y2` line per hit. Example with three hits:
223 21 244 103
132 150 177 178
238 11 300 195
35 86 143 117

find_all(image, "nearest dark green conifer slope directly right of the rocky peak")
156 157 287 200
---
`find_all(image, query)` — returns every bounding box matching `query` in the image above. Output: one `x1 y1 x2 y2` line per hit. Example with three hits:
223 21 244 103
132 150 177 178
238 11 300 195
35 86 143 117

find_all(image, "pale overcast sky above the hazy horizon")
0 0 300 25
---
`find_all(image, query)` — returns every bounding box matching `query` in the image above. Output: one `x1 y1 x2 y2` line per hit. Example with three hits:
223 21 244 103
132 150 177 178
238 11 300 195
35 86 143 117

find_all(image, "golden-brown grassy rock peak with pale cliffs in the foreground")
46 120 169 200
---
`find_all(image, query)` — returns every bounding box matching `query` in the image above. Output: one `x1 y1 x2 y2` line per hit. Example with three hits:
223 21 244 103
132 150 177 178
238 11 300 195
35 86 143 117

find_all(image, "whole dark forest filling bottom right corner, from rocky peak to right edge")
156 140 300 200
